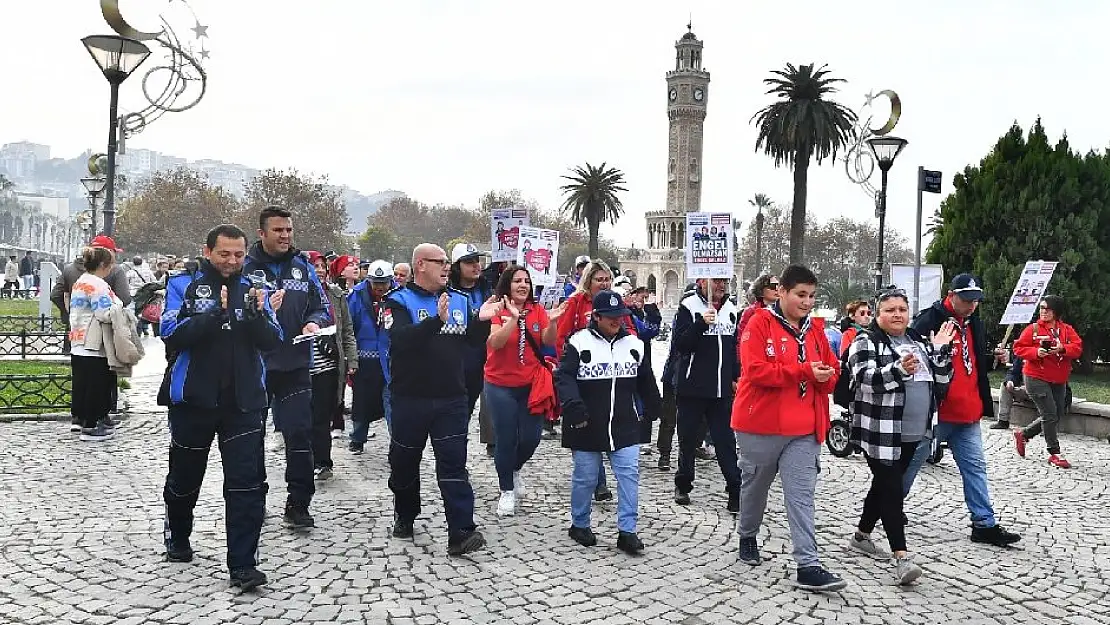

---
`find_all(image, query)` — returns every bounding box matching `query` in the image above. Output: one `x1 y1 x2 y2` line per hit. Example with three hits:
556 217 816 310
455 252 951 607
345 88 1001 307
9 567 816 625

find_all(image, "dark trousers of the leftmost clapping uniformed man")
162 405 269 569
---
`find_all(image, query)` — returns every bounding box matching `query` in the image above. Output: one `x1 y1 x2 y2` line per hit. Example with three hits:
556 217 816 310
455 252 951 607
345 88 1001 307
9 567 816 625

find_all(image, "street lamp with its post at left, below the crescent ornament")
81 34 150 236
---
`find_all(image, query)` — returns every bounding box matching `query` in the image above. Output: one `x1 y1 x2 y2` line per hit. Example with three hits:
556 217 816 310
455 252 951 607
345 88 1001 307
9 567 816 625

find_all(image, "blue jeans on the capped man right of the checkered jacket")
902 422 997 527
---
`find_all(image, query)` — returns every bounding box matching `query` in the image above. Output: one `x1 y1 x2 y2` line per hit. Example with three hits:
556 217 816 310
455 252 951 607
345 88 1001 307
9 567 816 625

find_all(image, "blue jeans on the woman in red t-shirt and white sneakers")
482 382 544 491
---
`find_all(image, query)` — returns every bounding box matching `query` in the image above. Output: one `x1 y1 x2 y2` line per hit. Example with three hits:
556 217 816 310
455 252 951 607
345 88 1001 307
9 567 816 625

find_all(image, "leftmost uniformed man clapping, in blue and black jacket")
159 224 282 591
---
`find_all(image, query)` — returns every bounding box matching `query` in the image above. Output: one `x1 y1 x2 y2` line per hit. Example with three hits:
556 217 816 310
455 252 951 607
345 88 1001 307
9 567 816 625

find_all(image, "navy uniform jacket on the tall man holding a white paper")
243 242 332 371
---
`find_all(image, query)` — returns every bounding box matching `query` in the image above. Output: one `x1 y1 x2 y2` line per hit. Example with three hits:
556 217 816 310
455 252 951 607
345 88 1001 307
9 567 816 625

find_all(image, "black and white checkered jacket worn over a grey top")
848 323 952 463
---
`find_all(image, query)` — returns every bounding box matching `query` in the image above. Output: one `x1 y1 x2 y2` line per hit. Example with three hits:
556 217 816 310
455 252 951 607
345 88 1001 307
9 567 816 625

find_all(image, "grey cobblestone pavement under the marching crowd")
0 342 1110 625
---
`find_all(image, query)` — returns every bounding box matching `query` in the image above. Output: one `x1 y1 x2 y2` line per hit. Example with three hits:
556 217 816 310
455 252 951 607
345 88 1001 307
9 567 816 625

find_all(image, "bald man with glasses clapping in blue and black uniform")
382 243 501 555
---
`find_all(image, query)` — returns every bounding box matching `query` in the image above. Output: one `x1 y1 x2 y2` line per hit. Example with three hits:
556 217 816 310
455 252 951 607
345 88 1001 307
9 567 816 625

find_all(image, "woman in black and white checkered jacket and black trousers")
847 289 956 584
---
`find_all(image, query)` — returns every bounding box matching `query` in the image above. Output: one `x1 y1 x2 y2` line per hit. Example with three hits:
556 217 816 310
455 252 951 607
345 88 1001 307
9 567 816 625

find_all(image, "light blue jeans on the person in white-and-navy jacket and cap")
572 442 639 534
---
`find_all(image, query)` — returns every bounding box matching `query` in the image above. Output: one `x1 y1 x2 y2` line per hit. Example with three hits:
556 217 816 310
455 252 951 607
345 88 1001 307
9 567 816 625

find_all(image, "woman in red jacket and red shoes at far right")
1013 295 1083 468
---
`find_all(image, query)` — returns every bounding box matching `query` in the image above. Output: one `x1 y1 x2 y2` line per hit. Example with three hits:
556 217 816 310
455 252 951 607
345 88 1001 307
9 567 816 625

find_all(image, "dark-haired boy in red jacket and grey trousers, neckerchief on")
733 265 847 591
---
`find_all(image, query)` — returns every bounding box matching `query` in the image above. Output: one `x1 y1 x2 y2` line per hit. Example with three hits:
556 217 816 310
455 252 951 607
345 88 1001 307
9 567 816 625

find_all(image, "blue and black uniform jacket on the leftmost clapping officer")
158 261 282 412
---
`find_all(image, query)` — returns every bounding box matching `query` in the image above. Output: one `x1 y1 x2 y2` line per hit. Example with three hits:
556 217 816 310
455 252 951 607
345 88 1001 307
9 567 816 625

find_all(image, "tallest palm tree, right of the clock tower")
751 63 856 263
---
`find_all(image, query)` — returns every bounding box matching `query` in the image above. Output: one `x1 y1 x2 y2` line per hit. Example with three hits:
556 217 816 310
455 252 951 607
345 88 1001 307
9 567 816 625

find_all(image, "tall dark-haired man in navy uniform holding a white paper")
243 206 332 528
